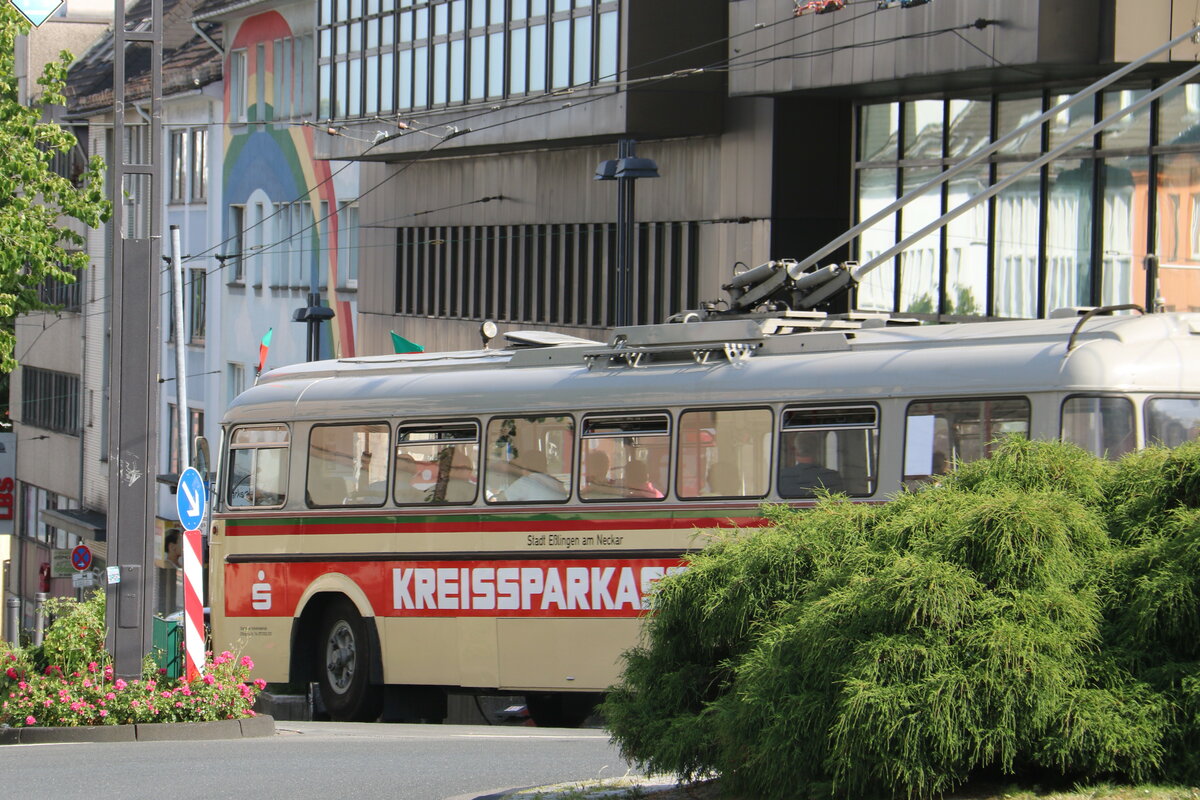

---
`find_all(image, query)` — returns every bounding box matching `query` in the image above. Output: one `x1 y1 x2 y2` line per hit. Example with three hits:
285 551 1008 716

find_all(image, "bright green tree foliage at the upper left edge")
0 2 110 372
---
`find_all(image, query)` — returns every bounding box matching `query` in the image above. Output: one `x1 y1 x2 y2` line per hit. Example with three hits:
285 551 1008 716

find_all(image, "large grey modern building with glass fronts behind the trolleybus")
317 0 1200 353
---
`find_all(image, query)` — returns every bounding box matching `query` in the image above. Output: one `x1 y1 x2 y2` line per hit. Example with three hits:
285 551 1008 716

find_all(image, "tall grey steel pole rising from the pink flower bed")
106 0 162 678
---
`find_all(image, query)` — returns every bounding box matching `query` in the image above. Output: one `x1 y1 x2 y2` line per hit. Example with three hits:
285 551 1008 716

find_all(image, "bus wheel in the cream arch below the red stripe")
317 597 383 722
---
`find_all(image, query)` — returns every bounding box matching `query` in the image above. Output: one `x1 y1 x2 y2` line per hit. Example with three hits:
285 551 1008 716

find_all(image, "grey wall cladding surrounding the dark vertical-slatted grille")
359 100 774 354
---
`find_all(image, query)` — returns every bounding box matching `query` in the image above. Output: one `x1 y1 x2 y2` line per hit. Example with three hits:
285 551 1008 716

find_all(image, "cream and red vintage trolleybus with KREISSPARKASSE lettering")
210 312 1200 724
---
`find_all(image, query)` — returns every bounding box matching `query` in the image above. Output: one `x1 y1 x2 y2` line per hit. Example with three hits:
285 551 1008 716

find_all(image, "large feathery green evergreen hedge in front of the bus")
604 438 1200 798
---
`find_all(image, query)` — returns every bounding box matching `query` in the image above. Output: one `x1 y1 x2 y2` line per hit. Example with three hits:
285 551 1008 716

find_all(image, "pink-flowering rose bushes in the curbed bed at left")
0 591 265 727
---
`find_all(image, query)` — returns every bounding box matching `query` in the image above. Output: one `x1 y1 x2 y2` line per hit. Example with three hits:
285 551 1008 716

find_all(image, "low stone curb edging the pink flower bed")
0 715 275 745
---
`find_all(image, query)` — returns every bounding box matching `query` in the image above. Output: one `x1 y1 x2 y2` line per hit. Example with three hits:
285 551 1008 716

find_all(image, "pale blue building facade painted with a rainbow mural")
194 1 359 381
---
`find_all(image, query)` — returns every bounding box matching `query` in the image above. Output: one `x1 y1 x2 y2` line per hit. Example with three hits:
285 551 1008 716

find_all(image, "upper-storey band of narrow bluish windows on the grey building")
317 0 620 119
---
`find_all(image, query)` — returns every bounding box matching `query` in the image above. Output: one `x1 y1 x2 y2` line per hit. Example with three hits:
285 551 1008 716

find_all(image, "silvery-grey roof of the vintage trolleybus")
226 313 1200 423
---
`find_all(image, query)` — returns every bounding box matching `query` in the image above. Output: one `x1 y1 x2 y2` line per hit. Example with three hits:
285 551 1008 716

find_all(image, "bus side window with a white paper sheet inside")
904 397 1030 486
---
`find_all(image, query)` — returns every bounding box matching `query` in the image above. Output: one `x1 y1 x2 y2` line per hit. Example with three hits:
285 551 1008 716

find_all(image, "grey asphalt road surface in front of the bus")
0 722 630 800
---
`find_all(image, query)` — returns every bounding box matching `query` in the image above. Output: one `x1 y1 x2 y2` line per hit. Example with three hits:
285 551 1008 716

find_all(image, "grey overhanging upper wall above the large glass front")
730 0 1200 97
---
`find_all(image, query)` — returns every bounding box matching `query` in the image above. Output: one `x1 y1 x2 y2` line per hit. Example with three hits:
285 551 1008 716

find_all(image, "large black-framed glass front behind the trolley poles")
854 84 1200 318
